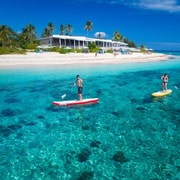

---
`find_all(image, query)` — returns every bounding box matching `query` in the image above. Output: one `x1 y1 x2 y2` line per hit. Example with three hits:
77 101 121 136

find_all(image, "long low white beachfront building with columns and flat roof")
39 35 128 50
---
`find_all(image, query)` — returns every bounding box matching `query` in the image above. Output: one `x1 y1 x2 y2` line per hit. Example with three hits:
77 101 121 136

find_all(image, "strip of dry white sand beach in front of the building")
0 52 172 68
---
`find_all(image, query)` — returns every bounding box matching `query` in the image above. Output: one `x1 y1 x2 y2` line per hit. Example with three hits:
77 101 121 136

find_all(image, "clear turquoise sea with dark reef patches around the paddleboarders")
0 53 180 180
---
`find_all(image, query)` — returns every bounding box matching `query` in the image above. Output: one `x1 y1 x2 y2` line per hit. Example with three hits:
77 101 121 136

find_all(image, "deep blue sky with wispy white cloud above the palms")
0 0 180 50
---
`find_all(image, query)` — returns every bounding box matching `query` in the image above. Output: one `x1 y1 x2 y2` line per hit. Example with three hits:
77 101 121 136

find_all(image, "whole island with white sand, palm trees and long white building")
0 21 171 68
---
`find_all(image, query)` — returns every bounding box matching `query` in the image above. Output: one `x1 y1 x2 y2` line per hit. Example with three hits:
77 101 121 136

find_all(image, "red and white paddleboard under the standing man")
52 98 99 106
